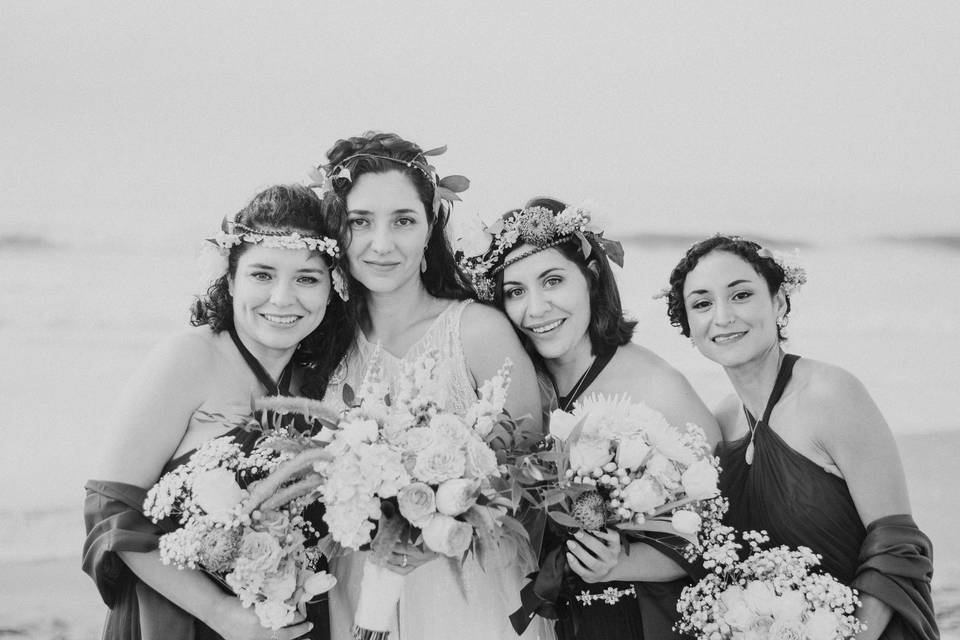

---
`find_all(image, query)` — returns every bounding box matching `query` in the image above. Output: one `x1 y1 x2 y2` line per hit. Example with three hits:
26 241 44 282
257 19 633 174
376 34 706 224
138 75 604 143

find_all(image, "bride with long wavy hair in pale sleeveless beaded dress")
324 133 545 640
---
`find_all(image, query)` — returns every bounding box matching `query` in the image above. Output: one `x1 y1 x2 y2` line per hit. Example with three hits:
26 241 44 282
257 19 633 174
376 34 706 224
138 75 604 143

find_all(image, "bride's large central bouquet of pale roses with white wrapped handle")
316 353 532 632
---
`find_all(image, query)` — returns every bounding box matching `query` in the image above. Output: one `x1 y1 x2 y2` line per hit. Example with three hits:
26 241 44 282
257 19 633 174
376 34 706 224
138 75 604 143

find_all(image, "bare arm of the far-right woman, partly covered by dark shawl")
804 367 910 640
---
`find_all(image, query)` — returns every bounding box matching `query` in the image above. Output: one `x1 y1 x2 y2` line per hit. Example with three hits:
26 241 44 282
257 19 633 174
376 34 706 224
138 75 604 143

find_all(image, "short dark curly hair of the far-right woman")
667 235 790 342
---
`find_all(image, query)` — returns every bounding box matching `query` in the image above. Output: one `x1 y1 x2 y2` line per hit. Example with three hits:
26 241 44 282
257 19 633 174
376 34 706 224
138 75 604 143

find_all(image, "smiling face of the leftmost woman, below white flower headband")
230 245 330 356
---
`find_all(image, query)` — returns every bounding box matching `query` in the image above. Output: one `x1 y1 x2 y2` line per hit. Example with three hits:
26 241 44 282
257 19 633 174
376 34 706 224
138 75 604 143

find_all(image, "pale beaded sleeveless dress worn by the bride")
326 300 553 640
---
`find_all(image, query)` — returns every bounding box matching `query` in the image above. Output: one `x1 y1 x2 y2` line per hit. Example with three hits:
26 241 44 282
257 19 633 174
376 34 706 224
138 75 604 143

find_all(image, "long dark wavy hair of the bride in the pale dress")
327 131 476 315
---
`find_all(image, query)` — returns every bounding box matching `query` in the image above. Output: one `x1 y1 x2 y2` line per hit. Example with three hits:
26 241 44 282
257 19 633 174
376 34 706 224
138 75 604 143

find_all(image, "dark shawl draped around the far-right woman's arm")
851 514 940 640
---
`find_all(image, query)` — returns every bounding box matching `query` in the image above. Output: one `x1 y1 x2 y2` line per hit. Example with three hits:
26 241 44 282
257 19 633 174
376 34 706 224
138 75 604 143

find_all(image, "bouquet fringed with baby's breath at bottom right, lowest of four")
676 527 864 640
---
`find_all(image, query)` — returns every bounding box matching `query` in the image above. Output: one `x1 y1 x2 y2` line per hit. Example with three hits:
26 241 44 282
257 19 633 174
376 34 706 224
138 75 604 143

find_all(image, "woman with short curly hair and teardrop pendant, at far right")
666 236 938 639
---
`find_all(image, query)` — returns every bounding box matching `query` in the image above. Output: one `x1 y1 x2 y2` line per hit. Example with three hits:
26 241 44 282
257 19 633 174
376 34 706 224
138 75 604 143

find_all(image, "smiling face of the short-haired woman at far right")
683 251 786 367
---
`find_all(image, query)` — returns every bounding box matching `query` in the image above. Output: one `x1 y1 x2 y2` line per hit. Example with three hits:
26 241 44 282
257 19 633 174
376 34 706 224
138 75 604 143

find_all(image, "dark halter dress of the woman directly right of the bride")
548 349 690 640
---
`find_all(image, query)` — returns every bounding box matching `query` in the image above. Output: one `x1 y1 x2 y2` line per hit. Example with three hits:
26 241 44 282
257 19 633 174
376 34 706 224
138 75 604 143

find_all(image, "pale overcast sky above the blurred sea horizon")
0 0 960 246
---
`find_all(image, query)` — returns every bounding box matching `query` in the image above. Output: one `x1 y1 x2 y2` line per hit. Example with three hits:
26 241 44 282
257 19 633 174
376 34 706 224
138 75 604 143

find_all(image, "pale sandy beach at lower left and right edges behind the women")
0 432 960 640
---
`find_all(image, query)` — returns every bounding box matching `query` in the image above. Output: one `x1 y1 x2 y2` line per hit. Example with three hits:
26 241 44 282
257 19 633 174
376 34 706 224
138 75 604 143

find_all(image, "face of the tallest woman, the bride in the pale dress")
346 171 430 293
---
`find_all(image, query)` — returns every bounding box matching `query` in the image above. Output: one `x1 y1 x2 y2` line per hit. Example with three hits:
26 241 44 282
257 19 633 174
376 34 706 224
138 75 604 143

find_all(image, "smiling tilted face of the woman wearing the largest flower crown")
503 245 591 360
